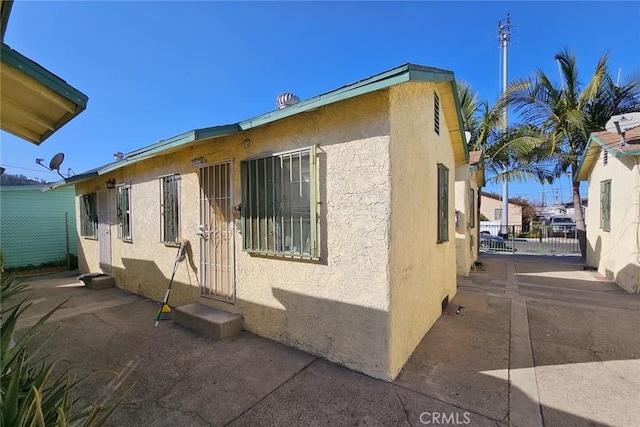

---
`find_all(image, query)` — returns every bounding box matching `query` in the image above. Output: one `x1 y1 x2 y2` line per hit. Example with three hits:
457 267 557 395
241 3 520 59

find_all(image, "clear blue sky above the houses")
0 0 640 203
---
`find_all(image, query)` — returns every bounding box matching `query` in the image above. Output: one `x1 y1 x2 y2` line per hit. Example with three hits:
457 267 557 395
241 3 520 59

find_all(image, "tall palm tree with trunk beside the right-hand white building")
506 48 640 257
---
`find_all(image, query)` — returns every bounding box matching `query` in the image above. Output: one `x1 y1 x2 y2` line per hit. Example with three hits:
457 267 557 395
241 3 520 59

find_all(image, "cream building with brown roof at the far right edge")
576 127 640 292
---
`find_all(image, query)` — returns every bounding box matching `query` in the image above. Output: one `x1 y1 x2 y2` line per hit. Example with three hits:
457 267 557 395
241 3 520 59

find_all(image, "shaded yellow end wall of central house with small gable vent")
389 83 456 378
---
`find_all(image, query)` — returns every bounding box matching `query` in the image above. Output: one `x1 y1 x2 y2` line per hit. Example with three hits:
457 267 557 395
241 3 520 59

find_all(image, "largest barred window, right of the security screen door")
242 147 318 258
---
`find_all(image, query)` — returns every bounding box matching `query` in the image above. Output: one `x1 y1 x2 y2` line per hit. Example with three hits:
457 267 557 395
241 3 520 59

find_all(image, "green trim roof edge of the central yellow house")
50 64 469 189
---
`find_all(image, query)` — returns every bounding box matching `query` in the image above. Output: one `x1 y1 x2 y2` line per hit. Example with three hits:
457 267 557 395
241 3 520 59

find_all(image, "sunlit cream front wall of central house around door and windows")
77 91 396 378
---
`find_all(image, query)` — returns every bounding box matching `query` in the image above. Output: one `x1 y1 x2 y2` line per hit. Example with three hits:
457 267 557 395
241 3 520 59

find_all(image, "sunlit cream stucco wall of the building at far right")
587 150 640 292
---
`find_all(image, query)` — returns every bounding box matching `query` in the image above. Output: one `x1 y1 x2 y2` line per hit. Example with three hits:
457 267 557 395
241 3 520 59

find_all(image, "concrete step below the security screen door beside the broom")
171 303 242 340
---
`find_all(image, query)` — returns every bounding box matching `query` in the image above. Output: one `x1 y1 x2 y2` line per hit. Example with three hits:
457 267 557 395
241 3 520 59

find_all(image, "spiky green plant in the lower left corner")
0 274 127 427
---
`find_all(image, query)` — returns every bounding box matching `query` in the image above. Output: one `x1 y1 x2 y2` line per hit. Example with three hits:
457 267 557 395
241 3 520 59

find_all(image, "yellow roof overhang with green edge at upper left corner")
0 43 88 145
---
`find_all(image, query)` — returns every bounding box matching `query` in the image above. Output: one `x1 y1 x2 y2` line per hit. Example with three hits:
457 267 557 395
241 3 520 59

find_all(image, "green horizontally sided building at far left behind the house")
0 185 78 268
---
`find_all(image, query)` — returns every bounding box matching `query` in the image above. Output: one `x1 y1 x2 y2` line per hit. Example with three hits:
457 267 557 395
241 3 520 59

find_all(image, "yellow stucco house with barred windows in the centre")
52 64 468 380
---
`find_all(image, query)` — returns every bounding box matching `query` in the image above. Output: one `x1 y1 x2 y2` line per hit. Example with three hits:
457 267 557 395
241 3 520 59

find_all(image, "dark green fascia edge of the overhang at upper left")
2 43 89 108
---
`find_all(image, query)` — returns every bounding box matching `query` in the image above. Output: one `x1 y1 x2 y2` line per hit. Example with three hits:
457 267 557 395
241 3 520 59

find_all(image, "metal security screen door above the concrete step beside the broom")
198 162 236 302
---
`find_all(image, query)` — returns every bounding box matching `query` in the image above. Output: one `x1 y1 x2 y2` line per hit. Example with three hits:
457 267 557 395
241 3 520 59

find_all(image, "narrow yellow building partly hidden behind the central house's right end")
455 151 484 276
